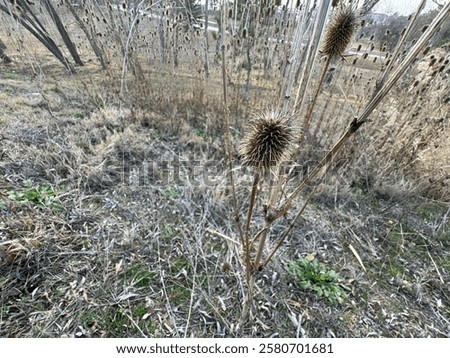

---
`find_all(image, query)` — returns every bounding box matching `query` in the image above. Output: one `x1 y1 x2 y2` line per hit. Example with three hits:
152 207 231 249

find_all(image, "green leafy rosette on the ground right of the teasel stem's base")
288 258 348 303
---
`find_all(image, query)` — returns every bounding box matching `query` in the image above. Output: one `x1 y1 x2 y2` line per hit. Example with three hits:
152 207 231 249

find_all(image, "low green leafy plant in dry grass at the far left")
8 180 63 211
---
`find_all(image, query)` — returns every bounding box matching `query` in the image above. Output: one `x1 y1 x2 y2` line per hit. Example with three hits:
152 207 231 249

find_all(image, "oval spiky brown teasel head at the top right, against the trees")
322 7 357 58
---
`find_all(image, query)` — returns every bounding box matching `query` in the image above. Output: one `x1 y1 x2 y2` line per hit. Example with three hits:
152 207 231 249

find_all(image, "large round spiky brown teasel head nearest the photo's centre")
239 111 294 170
